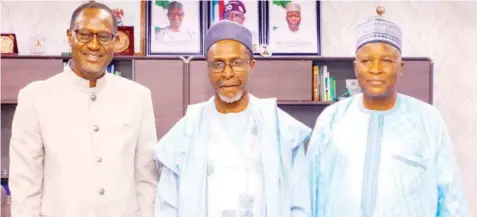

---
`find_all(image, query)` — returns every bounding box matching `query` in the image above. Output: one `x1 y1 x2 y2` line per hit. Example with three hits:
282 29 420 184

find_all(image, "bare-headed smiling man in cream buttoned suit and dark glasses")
9 2 159 217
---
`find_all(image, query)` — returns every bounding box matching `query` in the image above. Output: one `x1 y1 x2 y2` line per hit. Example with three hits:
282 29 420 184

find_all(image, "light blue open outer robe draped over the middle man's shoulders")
154 95 311 217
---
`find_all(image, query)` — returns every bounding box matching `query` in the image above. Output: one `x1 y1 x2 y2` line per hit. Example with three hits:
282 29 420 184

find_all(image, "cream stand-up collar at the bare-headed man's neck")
63 59 109 93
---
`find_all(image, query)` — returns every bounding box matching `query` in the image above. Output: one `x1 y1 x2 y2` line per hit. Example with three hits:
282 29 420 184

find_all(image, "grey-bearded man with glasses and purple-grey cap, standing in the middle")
151 20 311 217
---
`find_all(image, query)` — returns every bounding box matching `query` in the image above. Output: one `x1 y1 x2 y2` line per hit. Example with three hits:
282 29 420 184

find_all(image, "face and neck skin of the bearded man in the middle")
207 40 255 113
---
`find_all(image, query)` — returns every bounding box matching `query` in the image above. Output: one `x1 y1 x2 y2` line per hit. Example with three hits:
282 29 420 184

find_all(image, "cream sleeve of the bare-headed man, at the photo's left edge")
9 83 45 217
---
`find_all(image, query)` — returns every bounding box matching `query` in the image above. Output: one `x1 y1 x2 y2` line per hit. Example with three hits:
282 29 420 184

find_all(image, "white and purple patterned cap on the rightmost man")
356 7 402 52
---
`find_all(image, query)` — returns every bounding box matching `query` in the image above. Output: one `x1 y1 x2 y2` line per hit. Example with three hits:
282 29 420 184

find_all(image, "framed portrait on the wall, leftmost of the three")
146 0 204 56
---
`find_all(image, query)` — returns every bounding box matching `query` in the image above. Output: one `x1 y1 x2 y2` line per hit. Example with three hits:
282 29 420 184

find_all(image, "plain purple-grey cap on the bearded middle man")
205 20 253 56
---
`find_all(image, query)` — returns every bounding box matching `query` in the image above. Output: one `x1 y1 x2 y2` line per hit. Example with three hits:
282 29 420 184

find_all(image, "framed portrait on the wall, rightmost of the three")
265 0 321 56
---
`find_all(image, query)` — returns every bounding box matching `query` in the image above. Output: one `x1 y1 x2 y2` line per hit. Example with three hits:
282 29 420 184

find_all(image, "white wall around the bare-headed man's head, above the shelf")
0 0 141 55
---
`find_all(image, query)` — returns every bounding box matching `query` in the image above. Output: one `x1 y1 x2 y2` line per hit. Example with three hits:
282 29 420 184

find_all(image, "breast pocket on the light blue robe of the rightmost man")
391 153 428 194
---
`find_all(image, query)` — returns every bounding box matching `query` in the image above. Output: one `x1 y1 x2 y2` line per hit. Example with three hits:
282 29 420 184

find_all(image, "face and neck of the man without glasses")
354 42 404 111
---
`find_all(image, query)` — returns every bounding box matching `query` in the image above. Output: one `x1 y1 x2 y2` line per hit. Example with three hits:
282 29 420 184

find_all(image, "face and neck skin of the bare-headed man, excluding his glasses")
67 8 117 87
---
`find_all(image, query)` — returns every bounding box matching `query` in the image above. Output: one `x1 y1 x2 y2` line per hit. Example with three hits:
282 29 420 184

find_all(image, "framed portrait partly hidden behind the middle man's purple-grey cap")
207 0 263 53
